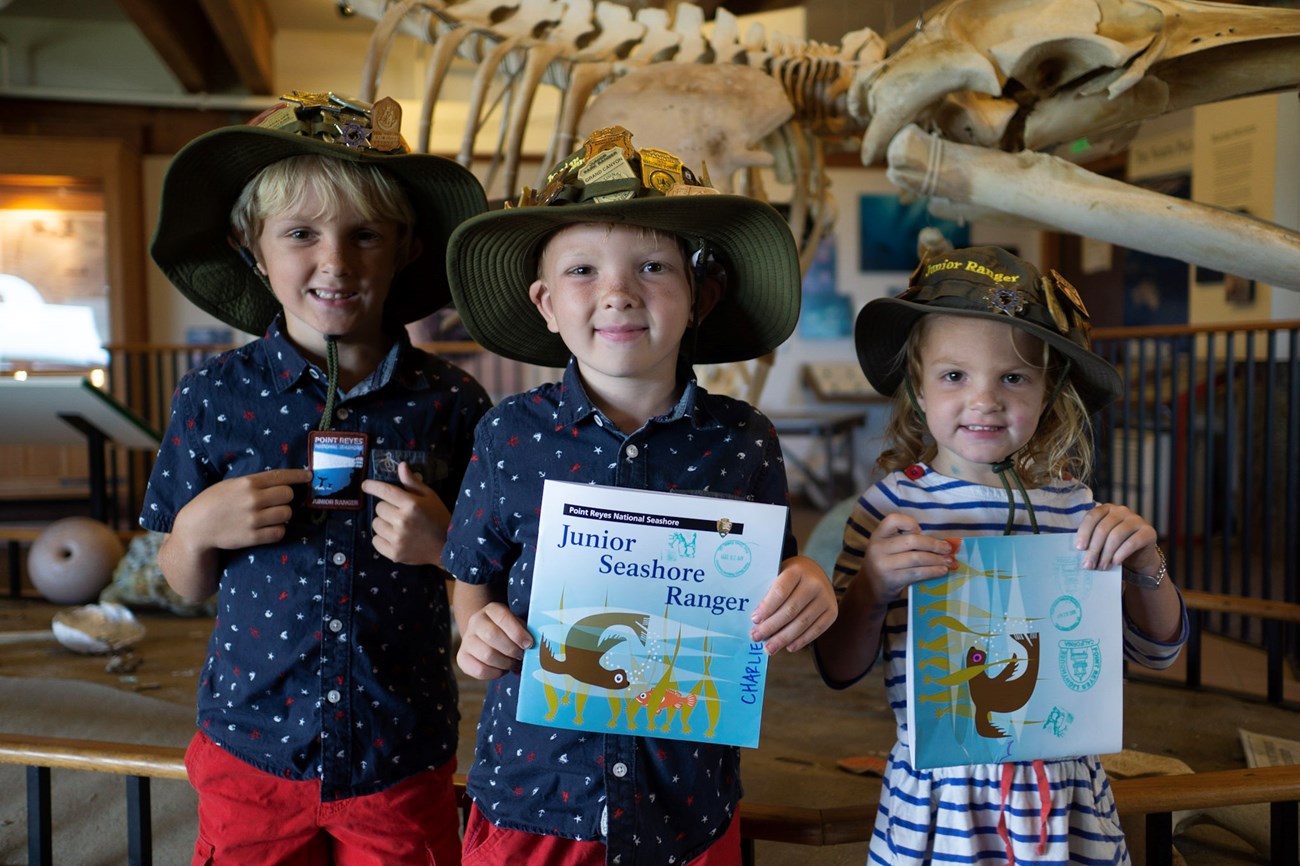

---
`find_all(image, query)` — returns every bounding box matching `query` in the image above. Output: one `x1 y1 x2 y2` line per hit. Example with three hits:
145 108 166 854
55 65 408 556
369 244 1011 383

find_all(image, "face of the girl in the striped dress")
917 313 1047 486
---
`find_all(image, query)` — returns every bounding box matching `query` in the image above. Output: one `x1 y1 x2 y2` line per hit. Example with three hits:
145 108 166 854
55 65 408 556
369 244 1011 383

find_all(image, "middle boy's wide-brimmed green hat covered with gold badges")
447 126 802 367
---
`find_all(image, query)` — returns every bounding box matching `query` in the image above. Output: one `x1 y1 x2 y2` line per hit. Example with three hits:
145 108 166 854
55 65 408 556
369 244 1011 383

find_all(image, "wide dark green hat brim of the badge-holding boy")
150 126 488 335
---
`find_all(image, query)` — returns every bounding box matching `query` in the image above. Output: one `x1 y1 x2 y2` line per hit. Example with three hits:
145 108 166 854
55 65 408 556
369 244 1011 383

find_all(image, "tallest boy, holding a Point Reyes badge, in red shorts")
140 92 489 866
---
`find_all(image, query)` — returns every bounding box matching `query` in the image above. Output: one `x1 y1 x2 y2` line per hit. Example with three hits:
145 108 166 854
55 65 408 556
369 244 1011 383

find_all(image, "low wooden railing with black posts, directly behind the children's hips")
0 733 1300 866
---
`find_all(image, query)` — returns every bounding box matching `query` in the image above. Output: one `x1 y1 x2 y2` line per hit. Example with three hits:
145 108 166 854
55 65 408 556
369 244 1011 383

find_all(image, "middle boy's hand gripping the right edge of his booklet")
749 557 837 655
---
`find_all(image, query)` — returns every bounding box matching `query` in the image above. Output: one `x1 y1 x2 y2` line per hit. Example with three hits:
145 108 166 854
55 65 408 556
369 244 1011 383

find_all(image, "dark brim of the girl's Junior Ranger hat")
853 298 1123 415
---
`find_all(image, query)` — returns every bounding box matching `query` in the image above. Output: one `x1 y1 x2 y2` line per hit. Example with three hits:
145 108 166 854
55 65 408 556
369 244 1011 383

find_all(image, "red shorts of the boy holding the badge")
185 732 460 866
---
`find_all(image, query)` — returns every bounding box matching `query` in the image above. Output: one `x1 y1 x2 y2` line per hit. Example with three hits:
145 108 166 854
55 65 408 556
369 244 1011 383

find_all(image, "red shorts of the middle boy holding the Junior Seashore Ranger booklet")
462 806 741 866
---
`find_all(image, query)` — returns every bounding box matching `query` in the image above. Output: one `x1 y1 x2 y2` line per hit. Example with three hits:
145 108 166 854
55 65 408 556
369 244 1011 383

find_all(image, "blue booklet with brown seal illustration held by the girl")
907 533 1123 770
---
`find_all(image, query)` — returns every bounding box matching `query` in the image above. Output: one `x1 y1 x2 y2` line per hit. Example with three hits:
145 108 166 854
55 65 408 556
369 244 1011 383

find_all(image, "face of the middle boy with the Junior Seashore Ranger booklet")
529 224 692 410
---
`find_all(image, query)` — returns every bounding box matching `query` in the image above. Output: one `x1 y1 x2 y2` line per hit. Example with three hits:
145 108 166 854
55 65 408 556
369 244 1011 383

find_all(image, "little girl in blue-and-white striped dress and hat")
815 240 1187 866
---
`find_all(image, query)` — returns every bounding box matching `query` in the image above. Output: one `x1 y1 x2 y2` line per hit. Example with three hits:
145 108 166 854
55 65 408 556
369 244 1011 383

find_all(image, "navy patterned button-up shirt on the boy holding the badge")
140 319 490 801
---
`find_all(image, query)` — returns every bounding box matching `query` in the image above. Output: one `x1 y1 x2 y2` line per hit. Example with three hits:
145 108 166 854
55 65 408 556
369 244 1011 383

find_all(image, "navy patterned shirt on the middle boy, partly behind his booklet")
442 361 796 866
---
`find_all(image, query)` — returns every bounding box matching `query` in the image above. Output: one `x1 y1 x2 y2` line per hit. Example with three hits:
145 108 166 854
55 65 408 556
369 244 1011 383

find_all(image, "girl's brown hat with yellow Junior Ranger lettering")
853 247 1123 413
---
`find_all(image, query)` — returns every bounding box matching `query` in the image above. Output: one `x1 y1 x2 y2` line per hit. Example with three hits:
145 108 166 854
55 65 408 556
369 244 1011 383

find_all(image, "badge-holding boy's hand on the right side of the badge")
361 460 451 566
